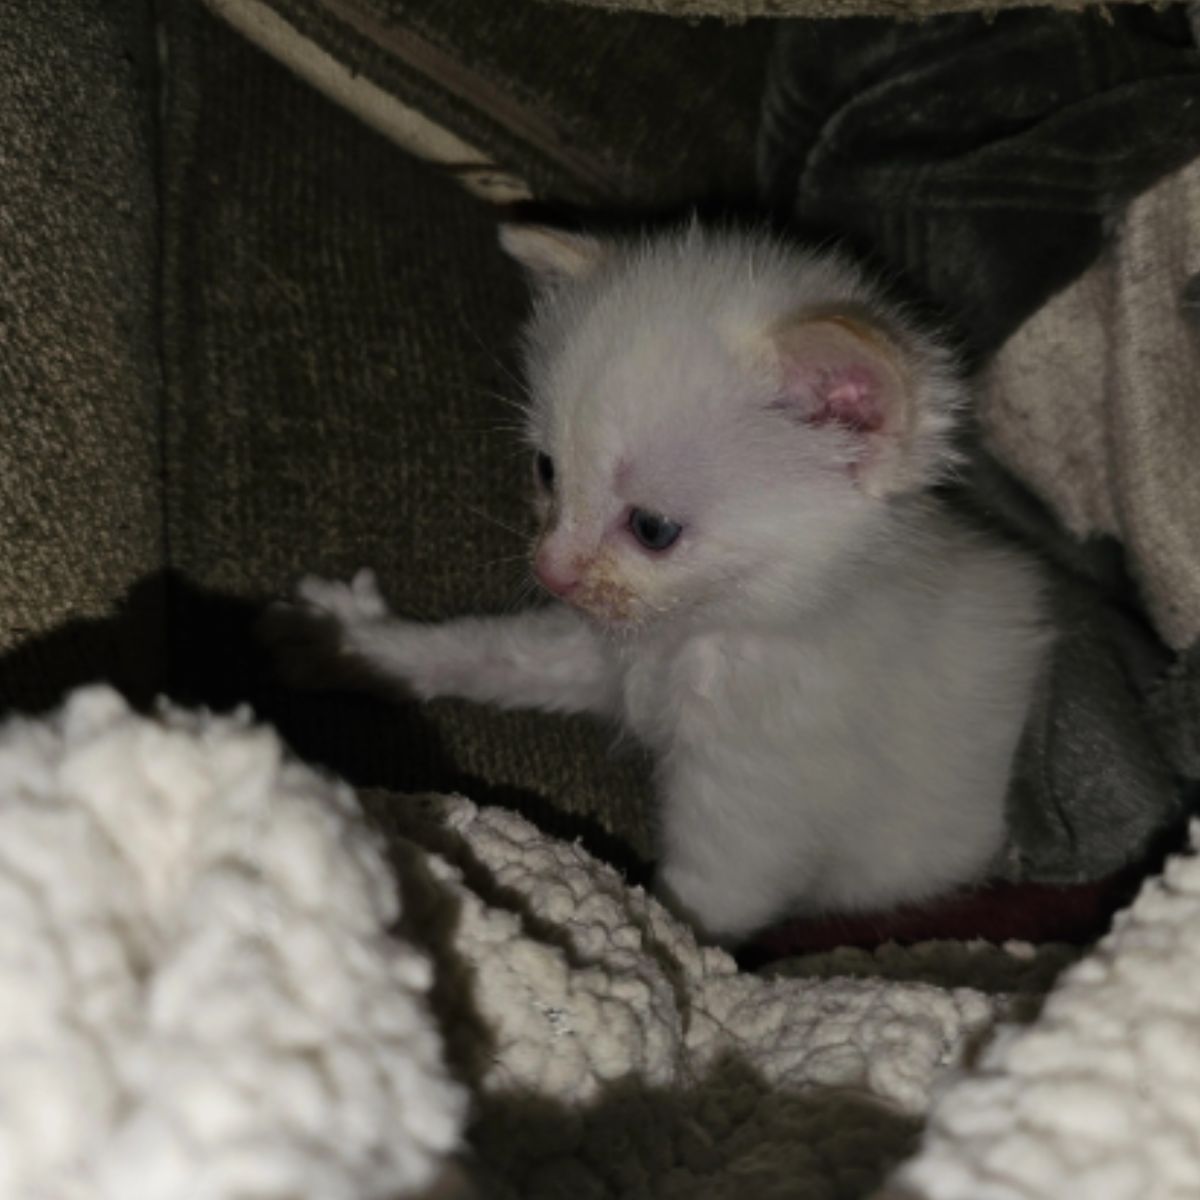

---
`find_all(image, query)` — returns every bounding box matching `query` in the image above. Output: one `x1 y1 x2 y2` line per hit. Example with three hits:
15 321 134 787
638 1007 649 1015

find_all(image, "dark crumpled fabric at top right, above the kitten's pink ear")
758 5 1200 354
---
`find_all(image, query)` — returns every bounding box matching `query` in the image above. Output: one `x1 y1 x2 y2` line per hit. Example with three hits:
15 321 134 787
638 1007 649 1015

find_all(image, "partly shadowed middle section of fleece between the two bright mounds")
391 798 1003 1200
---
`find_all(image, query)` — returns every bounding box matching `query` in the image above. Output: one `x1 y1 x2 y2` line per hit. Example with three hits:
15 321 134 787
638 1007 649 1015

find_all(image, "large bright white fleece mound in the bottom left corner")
0 688 466 1200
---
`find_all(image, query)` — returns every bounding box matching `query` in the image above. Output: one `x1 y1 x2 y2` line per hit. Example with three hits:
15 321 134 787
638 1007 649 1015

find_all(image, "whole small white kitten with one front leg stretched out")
274 220 1046 940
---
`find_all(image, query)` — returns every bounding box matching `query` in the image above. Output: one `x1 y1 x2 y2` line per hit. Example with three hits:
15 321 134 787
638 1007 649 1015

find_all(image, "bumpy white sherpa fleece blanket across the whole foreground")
0 689 1200 1200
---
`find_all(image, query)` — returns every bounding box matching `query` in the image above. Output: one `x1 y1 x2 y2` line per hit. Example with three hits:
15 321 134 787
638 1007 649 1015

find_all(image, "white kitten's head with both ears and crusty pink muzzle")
502 226 959 629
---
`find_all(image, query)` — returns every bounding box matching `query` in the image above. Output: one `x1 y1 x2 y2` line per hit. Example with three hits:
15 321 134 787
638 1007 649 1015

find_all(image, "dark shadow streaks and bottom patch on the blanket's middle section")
350 806 931 1200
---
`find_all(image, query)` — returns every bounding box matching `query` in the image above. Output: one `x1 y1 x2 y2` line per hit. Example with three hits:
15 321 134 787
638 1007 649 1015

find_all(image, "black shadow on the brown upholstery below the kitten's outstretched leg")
0 571 650 884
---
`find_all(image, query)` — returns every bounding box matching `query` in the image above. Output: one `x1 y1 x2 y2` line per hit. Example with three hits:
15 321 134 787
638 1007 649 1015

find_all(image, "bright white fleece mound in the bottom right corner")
888 826 1200 1200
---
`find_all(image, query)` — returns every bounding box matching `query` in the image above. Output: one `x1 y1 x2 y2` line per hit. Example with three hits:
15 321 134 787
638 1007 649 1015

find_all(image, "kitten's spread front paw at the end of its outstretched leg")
257 570 388 688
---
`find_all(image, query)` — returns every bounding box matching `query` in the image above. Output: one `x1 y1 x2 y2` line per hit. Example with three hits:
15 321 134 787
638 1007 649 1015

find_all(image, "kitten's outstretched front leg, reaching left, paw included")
264 570 619 714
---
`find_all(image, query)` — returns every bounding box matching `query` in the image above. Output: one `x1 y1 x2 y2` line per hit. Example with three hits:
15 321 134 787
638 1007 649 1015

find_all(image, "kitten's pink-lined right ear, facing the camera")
770 314 956 496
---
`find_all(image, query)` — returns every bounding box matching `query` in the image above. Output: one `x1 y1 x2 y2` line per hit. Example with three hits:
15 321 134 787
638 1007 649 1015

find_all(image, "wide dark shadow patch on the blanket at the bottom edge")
469 1057 920 1200
